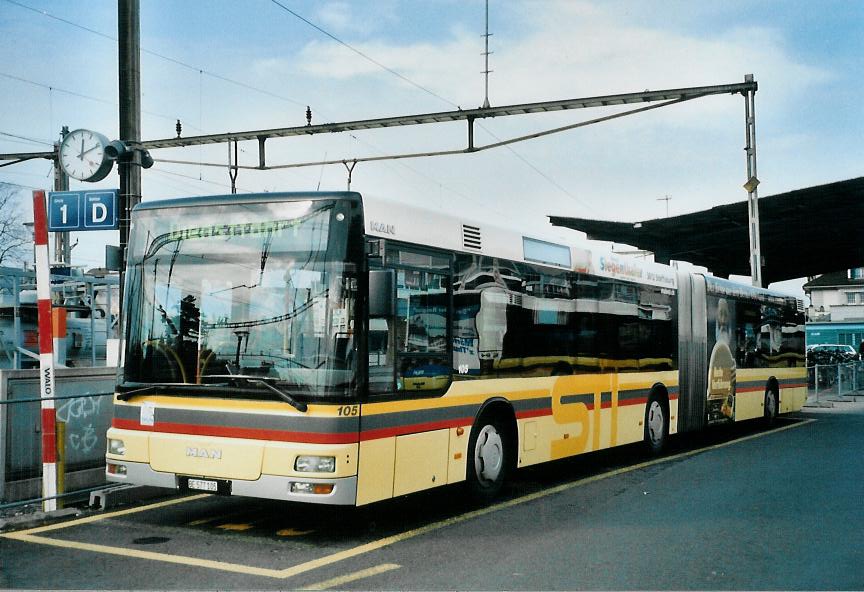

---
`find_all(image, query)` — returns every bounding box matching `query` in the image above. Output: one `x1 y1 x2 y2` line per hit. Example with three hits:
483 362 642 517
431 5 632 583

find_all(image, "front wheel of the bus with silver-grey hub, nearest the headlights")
466 415 511 501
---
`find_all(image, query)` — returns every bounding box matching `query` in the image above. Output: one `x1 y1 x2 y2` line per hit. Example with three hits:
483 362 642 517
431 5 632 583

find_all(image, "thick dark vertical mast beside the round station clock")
117 0 141 312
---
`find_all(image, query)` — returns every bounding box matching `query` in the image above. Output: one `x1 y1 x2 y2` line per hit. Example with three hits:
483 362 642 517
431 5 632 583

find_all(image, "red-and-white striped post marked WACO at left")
33 191 57 512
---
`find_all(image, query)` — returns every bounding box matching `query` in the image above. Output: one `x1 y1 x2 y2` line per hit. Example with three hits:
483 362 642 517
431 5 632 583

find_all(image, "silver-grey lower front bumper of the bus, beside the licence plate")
105 458 357 506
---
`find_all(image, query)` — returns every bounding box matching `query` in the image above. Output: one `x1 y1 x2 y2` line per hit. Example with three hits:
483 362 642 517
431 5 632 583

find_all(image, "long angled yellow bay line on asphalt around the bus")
0 419 816 583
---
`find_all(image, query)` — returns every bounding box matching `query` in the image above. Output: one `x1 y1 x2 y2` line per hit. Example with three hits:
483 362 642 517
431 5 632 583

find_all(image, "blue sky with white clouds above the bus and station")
0 0 864 293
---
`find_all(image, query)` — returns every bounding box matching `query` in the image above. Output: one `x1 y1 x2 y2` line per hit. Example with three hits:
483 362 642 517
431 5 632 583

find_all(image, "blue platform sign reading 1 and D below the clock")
48 189 120 232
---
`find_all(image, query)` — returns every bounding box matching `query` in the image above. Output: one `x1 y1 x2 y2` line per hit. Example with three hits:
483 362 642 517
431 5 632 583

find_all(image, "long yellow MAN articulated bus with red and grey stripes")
106 192 806 505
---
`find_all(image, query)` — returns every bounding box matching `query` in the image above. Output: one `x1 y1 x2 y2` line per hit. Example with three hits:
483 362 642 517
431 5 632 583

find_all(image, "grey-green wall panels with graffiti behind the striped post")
0 367 116 508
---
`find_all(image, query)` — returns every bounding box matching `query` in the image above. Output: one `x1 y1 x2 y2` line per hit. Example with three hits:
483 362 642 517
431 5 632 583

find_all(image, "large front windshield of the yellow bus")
124 200 357 398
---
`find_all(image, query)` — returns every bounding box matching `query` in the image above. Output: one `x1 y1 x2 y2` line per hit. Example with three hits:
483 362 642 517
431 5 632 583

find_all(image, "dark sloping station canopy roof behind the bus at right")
549 177 864 286
